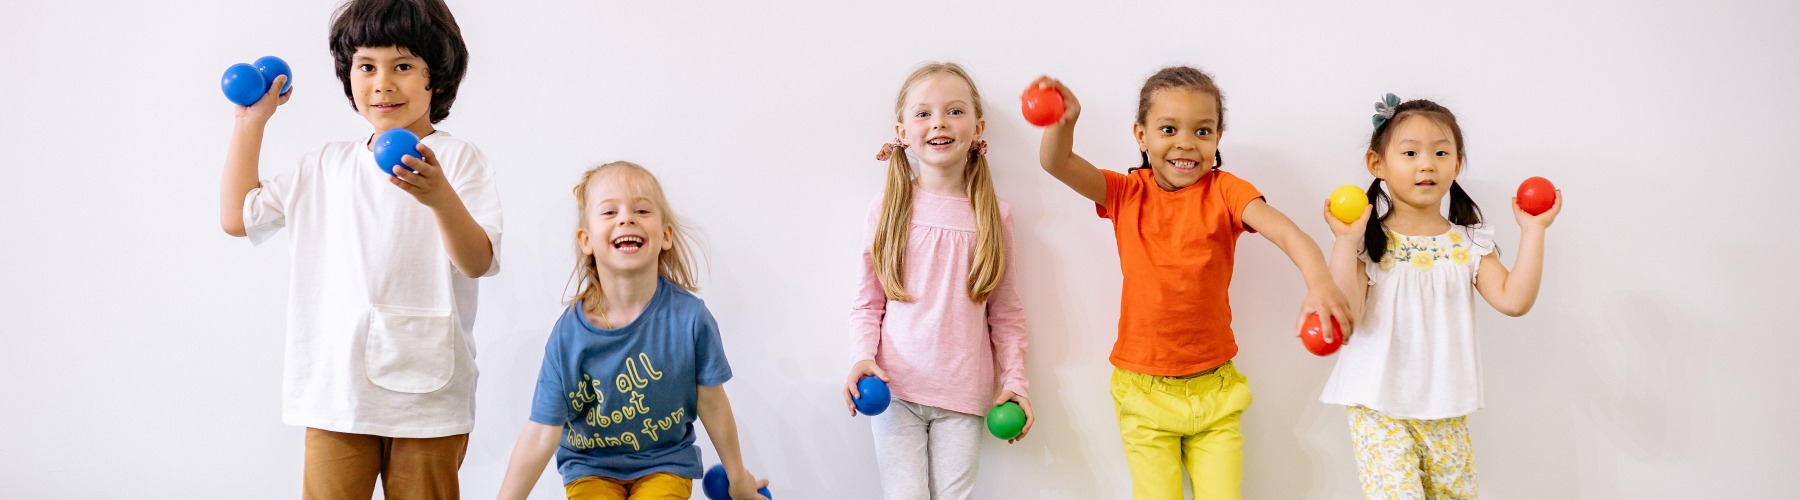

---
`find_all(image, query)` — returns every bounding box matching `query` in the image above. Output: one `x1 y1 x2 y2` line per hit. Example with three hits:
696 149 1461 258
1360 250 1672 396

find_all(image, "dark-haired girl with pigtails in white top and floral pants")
1319 94 1562 498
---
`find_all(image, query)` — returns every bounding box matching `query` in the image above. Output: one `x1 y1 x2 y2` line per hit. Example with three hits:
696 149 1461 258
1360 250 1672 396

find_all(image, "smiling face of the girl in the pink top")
895 72 986 169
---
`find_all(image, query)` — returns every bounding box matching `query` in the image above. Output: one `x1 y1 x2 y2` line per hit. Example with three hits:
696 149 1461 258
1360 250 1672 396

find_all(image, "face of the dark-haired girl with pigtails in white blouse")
1368 113 1462 212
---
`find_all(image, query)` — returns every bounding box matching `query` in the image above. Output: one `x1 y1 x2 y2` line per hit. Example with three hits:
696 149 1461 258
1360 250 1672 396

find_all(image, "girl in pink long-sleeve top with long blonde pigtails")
844 63 1033 500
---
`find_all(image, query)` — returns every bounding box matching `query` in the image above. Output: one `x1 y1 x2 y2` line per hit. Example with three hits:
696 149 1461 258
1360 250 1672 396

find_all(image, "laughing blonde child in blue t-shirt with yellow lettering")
500 162 769 500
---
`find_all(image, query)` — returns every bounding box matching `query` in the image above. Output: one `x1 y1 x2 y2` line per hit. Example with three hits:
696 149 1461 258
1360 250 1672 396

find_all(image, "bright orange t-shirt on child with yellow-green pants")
1096 169 1262 376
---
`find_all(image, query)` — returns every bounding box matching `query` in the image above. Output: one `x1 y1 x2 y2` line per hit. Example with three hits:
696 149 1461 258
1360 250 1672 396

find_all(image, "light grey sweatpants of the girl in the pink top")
871 399 986 500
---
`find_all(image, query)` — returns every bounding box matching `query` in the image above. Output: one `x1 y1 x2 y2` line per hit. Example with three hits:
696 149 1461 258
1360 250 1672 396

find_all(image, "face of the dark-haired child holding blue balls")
349 47 432 137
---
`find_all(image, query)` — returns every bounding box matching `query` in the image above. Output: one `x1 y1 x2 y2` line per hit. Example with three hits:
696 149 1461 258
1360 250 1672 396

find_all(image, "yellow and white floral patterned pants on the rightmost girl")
1350 406 1476 500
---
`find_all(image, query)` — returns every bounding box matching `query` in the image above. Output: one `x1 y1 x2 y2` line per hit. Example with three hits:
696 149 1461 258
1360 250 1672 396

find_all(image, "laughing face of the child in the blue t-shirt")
574 169 675 277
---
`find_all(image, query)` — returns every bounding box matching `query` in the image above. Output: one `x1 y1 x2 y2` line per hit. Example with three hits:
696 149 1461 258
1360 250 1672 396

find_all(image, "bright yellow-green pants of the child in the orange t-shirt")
1112 363 1249 500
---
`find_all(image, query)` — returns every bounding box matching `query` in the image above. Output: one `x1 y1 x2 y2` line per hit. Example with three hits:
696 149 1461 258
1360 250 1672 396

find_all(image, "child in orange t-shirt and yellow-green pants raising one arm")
1033 67 1346 498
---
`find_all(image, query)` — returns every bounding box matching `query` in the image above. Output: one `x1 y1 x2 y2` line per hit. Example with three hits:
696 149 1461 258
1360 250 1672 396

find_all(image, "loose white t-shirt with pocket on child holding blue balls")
243 129 500 437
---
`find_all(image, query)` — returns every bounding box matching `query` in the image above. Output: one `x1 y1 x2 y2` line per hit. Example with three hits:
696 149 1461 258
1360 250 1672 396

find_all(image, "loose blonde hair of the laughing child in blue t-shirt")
569 162 700 308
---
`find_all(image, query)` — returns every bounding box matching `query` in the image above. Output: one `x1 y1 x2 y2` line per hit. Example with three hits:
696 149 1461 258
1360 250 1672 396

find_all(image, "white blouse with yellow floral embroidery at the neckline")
1319 225 1494 421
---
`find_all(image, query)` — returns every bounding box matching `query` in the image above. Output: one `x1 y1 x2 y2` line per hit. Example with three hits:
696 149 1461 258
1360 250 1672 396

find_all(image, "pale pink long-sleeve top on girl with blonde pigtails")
850 189 1030 415
